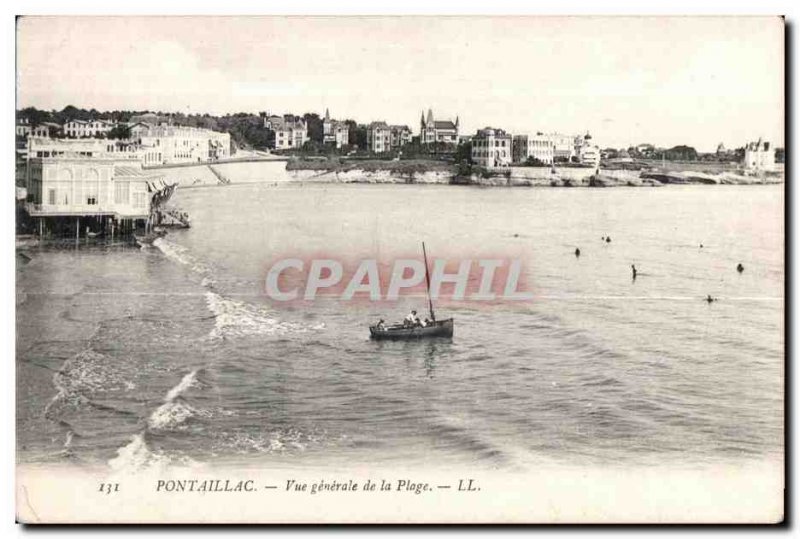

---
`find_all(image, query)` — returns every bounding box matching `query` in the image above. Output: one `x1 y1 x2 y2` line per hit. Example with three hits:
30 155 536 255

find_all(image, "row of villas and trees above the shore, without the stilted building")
16 106 784 171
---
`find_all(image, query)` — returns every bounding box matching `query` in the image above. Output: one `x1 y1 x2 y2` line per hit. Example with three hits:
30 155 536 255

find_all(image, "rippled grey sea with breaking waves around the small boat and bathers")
16 174 785 470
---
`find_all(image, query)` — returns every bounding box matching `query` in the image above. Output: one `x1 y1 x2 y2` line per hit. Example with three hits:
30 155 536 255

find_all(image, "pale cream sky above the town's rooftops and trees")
17 16 784 151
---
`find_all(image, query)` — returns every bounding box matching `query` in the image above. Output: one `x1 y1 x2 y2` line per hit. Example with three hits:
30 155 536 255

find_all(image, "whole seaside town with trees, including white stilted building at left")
16 106 784 237
